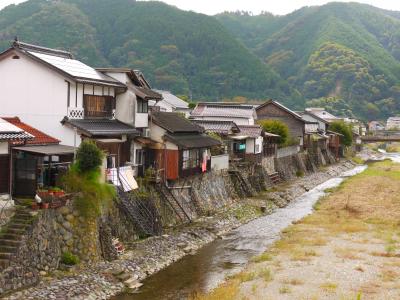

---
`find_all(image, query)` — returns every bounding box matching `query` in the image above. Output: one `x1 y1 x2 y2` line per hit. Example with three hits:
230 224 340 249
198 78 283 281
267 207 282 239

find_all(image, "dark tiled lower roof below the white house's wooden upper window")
62 118 139 137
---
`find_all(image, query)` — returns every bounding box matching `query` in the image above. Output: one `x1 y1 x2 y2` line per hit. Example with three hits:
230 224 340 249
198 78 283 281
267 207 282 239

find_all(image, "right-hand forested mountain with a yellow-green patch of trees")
217 3 400 118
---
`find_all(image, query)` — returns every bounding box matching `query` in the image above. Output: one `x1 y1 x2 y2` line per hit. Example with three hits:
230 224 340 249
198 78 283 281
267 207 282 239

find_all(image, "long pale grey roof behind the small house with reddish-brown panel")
191 103 255 119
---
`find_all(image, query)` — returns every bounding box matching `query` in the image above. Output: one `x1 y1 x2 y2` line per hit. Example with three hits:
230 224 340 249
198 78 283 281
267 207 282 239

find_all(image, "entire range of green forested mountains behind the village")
0 0 400 118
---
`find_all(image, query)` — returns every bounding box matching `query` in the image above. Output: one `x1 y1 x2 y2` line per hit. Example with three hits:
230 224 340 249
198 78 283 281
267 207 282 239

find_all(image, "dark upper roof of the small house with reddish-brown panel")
151 112 204 133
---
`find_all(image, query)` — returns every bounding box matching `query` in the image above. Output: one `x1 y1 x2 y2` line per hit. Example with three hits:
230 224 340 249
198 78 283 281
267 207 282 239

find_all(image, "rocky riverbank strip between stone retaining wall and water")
6 161 354 299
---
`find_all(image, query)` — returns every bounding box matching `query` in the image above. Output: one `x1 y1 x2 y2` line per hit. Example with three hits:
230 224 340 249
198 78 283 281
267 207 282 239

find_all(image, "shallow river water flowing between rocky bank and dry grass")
115 166 367 300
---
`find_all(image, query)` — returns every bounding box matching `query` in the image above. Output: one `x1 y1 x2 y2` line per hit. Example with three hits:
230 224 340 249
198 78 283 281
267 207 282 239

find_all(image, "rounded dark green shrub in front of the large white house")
76 141 104 172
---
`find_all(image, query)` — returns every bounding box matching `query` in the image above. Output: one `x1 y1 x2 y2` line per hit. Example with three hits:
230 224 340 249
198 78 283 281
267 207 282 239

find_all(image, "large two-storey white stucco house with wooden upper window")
0 40 162 176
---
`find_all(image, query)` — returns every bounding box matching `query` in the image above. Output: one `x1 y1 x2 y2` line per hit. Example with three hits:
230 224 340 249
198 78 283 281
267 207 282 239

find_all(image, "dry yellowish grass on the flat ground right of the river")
198 161 400 300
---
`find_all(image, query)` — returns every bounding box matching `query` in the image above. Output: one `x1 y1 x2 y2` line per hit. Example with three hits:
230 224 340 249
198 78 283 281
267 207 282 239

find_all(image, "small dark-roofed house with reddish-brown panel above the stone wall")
146 112 221 180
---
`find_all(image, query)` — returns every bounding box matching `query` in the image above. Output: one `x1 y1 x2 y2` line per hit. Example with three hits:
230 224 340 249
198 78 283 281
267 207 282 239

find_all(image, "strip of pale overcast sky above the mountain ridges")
0 0 400 15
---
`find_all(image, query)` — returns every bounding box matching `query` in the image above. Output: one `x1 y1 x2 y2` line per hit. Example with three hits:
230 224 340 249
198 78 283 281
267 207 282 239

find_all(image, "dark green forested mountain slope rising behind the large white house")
0 0 290 100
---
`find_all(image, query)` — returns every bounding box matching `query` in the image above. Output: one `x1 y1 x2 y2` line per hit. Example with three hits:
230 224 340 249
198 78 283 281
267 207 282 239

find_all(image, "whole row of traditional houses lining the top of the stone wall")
0 40 354 200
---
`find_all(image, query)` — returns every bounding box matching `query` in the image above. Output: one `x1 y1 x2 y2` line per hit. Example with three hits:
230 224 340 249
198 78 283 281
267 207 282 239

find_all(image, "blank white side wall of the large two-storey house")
0 53 115 146
